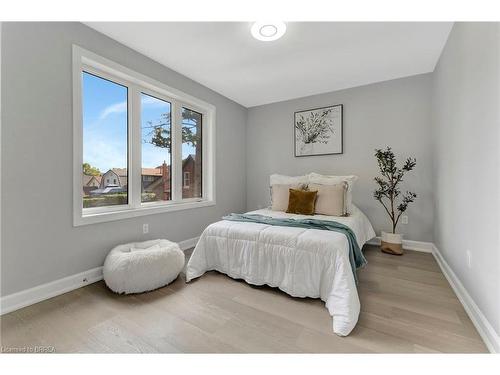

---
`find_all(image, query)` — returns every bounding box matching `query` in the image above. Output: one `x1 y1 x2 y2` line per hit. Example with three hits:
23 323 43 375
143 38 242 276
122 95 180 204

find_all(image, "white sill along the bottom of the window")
73 200 215 227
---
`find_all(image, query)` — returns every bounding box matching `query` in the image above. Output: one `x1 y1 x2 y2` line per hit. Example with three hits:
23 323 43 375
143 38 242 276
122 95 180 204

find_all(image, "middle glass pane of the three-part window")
141 94 172 202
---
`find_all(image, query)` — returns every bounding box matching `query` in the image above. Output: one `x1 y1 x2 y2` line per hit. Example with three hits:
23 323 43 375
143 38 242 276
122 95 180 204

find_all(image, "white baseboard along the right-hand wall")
432 245 500 353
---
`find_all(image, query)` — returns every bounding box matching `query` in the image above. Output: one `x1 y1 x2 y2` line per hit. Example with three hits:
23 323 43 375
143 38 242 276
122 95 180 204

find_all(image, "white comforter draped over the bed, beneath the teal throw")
186 207 375 336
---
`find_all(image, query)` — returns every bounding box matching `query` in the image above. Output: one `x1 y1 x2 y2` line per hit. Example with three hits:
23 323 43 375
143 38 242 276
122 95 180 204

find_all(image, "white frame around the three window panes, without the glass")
73 45 216 226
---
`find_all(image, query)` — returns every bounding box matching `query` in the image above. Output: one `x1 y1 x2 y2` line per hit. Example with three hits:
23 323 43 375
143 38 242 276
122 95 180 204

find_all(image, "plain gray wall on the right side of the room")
433 23 500 333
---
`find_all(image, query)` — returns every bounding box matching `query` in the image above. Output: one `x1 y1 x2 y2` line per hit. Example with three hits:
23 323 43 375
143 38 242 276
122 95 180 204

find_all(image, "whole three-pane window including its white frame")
73 46 215 225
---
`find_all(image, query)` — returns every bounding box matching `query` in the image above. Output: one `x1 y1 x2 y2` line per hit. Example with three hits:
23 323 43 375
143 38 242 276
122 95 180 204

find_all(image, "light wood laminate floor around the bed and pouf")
1 246 487 353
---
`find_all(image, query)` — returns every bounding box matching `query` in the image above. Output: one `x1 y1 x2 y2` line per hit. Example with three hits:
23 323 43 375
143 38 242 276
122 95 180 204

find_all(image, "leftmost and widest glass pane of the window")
82 72 128 208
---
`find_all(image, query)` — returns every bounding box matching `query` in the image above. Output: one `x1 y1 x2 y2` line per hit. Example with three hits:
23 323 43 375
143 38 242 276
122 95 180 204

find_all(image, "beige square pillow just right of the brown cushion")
309 182 347 216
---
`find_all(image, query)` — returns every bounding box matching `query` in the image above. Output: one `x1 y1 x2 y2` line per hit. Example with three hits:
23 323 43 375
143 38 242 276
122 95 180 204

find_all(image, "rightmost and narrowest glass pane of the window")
182 108 203 198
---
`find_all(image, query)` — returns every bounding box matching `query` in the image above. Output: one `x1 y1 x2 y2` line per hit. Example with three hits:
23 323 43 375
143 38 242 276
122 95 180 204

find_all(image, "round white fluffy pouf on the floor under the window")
103 240 185 294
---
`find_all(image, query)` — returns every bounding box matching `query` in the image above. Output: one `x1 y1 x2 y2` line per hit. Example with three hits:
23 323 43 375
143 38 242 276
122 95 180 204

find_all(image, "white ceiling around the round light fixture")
87 22 452 107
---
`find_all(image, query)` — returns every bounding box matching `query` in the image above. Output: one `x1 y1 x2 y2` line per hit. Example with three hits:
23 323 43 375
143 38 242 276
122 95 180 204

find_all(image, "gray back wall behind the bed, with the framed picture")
247 74 433 241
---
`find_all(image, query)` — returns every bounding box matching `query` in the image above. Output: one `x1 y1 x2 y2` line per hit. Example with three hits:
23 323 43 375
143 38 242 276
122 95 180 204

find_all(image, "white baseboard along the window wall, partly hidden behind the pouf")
0 237 199 315
